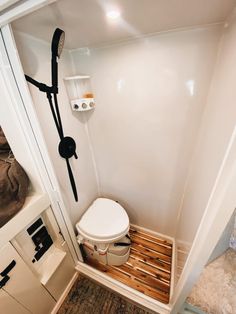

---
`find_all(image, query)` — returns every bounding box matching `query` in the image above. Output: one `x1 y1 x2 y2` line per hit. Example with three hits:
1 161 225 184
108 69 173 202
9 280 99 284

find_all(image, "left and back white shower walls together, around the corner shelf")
14 25 222 236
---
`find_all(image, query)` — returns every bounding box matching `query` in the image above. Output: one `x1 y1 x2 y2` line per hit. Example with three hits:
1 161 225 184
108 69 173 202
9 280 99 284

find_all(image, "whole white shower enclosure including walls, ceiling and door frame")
0 0 236 313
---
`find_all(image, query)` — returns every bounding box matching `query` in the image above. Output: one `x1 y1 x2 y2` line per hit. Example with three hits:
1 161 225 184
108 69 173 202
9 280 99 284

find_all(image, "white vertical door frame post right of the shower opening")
170 127 236 314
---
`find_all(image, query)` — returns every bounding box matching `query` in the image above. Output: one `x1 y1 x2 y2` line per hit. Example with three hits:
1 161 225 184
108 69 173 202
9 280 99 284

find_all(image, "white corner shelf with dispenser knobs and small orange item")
64 75 95 111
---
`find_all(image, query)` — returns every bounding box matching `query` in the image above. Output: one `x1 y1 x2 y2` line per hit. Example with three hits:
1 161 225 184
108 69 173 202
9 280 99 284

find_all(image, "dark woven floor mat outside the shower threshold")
58 276 154 314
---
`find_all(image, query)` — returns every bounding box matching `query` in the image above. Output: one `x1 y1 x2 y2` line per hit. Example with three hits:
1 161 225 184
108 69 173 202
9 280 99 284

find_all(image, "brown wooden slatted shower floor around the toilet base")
87 229 172 303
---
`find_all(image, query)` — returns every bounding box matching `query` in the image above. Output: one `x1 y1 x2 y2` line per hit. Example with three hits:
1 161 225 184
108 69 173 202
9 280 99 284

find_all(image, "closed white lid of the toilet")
76 198 129 243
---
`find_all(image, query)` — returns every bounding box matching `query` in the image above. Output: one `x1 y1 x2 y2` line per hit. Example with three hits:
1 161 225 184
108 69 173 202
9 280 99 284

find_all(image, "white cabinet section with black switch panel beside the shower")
11 206 75 301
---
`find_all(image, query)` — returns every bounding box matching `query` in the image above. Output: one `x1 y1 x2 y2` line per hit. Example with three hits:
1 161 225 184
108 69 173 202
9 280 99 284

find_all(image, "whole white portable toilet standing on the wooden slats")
76 198 131 266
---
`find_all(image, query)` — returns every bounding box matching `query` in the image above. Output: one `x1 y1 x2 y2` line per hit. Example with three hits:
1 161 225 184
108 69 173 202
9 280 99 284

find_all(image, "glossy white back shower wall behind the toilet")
71 25 221 236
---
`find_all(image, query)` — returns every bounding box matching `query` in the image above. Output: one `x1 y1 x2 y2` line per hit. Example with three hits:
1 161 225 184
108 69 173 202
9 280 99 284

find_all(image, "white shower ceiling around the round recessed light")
13 0 236 49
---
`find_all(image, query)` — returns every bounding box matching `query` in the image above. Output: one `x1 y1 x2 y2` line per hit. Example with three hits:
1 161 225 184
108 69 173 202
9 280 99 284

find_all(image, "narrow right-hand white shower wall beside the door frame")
176 12 236 268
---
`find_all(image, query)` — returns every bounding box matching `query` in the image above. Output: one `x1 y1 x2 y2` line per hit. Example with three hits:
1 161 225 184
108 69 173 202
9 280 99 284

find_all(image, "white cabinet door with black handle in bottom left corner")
0 243 56 314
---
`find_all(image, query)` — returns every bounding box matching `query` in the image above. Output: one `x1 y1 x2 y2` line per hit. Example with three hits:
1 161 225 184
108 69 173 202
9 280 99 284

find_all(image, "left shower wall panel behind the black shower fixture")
14 30 98 224
